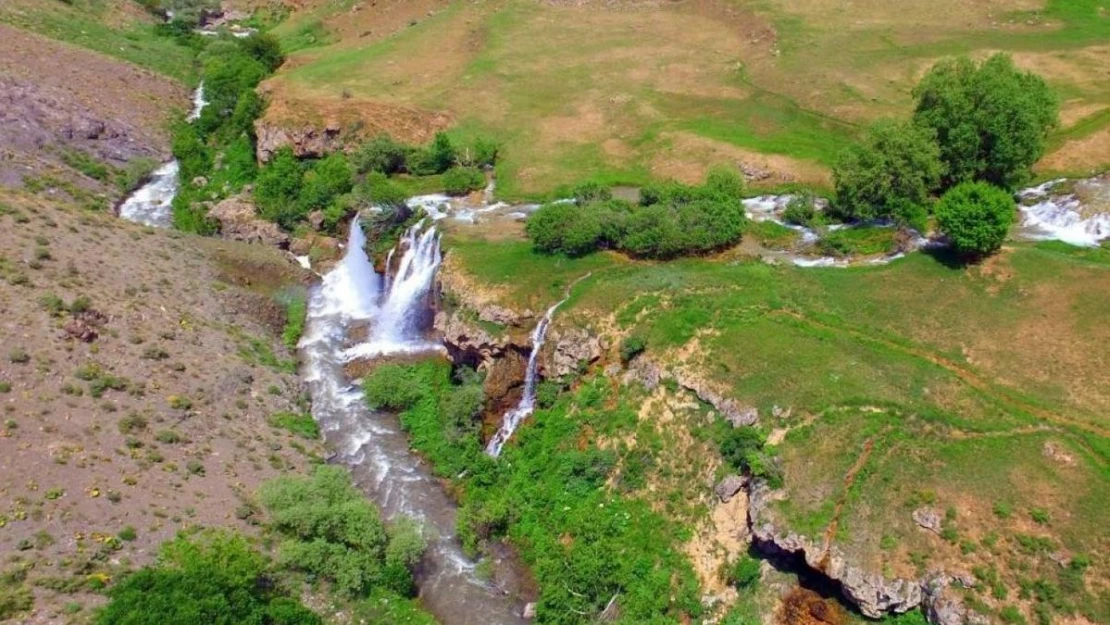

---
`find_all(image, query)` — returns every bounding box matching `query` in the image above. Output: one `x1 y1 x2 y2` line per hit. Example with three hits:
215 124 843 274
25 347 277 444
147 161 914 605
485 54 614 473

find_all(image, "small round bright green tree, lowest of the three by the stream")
936 182 1015 256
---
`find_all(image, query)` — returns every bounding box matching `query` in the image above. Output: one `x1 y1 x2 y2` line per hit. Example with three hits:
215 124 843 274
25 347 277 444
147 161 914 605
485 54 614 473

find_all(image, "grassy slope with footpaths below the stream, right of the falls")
448 233 1110 622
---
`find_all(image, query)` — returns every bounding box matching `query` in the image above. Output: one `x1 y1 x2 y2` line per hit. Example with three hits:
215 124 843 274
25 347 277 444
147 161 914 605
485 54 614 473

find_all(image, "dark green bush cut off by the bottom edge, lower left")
95 532 322 625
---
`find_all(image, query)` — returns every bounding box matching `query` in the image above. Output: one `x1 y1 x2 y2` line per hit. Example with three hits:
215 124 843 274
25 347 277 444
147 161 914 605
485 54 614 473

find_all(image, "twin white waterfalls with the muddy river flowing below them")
300 220 527 625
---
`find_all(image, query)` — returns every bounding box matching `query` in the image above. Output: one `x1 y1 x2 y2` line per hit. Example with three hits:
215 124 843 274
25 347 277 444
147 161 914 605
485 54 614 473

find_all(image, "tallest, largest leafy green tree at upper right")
914 54 1058 189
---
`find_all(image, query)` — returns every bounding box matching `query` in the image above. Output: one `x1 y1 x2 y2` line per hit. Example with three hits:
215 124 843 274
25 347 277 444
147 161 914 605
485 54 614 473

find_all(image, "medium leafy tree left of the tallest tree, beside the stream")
833 121 944 223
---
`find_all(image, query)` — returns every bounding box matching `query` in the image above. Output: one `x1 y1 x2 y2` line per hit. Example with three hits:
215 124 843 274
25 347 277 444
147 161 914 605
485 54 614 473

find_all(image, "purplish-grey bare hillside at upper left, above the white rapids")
0 24 189 191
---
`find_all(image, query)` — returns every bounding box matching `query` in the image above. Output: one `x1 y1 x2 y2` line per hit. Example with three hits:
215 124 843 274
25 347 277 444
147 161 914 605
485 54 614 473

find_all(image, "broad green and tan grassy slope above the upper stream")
271 0 1110 196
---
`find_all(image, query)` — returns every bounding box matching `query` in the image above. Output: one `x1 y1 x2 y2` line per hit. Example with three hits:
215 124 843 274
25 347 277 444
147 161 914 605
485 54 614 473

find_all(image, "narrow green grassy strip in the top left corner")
0 0 194 82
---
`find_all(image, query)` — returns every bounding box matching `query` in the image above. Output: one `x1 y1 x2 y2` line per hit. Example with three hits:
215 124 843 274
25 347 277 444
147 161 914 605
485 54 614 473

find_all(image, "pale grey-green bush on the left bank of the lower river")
259 466 425 596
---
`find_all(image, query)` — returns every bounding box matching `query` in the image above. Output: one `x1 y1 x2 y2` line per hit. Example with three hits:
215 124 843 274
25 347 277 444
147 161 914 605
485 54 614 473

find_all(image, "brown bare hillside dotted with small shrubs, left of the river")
0 190 321 623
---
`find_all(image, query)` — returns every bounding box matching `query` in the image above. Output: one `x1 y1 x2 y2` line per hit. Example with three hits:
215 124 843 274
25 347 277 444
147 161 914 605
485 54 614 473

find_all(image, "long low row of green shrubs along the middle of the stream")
525 171 747 259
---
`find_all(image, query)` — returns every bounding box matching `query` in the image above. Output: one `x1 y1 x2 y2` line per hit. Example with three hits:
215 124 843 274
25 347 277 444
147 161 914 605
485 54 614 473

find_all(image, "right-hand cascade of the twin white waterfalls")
346 220 443 359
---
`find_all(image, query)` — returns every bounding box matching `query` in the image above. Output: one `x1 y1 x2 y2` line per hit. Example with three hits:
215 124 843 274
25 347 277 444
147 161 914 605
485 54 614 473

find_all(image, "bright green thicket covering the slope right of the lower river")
372 360 700 625
